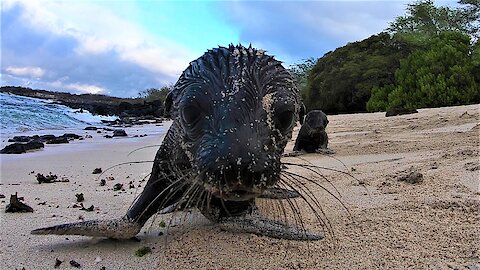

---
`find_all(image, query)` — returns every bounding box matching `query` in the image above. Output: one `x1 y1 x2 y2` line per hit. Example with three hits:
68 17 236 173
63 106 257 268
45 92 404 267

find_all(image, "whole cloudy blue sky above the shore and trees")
0 0 455 97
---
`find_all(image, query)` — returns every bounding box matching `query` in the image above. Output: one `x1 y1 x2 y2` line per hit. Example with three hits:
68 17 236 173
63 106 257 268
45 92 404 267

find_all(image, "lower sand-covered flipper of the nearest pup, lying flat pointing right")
219 215 325 241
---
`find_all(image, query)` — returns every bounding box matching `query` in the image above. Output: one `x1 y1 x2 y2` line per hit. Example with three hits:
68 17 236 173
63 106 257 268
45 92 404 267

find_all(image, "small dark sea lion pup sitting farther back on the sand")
293 110 334 154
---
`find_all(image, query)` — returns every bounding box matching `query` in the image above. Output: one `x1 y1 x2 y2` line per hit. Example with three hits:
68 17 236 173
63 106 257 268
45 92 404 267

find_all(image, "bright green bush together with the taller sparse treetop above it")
367 0 480 111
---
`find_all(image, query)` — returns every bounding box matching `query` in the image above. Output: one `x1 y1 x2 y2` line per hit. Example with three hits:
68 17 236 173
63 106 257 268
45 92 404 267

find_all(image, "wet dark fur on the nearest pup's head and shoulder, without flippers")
127 46 298 224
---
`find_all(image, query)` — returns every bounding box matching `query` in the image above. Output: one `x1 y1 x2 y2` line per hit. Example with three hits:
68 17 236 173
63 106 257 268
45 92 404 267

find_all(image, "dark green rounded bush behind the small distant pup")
302 33 410 113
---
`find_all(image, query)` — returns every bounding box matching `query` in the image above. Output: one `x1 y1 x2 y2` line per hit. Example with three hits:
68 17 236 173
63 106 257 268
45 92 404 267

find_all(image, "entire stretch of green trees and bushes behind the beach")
291 0 480 113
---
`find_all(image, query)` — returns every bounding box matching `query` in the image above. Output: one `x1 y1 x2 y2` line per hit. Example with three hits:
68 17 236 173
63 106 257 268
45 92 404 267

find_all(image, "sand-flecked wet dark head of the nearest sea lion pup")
168 46 299 201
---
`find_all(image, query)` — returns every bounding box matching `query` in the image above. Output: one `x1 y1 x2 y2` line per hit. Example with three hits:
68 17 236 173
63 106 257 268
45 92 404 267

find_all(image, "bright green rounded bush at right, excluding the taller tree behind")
367 32 480 111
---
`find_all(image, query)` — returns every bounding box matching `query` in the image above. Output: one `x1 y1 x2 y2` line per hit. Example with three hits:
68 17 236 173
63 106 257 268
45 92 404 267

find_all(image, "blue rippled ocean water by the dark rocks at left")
0 93 116 137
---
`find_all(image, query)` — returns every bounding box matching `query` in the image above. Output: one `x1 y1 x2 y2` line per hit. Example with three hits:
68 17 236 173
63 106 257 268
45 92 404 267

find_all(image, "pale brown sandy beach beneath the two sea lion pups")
0 105 480 269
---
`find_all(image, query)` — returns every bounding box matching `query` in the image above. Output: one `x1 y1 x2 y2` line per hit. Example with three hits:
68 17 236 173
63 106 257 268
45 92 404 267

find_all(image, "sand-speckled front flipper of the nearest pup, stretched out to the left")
31 216 143 239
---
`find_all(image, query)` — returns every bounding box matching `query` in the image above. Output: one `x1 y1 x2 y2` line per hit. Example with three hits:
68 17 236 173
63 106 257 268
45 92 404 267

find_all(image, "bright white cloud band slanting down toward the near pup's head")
2 0 194 79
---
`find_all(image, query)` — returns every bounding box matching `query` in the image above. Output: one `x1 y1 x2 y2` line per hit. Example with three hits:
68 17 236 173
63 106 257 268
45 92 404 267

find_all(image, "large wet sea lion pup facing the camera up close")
32 45 323 240
